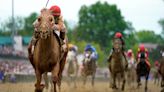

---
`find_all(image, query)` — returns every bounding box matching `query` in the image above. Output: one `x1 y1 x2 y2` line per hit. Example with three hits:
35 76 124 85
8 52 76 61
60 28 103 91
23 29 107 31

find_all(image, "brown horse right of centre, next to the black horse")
108 38 126 90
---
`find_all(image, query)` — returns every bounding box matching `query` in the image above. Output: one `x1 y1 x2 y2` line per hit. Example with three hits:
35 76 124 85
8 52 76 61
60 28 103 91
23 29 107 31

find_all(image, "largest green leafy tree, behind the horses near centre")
75 1 128 48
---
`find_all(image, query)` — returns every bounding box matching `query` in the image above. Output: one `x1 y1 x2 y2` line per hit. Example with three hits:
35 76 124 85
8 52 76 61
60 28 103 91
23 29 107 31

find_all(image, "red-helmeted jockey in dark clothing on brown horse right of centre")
107 32 127 62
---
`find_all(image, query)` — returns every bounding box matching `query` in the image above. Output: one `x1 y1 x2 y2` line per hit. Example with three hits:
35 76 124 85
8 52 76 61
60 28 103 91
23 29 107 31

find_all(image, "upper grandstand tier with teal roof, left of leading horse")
0 36 31 59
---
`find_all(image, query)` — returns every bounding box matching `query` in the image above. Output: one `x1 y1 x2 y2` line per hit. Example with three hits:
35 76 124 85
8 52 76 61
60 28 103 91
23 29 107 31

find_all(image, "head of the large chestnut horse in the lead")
37 8 54 39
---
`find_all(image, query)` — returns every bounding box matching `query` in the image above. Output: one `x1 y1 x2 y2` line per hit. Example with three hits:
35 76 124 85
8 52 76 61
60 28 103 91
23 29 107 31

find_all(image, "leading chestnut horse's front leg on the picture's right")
52 62 60 92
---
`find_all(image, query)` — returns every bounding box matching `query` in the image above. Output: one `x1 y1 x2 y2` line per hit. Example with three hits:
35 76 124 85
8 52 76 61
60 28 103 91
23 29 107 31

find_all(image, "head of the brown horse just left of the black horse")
113 38 122 53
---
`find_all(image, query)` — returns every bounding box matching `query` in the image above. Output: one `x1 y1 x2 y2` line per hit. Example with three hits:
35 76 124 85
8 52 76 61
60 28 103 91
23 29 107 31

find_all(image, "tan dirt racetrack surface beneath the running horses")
0 81 160 92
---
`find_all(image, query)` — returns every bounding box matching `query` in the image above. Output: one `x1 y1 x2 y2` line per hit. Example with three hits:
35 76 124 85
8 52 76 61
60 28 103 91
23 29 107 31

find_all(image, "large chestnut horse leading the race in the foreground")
30 8 67 92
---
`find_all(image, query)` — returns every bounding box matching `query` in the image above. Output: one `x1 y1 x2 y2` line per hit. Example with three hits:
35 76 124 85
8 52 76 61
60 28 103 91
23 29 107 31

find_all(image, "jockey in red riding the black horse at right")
136 44 150 67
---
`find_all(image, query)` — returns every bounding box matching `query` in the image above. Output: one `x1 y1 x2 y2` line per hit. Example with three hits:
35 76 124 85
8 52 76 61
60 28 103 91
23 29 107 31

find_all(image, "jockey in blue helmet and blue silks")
84 44 98 61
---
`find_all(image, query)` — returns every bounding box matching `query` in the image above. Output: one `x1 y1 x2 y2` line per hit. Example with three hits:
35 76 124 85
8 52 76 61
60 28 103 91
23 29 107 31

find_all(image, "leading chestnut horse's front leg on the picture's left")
35 70 44 92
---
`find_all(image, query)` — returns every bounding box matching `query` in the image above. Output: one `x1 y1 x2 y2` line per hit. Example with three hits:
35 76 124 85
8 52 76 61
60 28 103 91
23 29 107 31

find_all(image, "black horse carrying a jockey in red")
136 53 150 92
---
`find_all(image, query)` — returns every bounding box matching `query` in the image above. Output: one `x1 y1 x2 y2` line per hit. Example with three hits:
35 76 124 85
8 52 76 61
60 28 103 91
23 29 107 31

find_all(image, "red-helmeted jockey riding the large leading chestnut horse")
28 5 67 58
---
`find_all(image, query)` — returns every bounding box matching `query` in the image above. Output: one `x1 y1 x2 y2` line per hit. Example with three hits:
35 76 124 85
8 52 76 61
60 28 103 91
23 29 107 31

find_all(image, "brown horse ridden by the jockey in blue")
81 51 96 86
